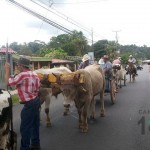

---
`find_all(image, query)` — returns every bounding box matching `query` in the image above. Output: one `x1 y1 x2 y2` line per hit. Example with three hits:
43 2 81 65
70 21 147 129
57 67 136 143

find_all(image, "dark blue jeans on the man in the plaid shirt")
20 97 40 150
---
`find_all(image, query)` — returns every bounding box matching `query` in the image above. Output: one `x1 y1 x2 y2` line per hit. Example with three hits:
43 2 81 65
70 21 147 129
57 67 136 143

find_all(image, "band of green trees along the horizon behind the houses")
2 30 150 63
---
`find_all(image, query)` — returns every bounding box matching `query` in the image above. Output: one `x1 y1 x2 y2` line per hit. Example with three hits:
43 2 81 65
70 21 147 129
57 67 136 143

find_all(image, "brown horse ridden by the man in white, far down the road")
128 62 136 82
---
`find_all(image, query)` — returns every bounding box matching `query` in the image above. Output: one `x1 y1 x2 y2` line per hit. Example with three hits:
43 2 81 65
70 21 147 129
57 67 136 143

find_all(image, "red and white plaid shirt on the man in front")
8 71 40 102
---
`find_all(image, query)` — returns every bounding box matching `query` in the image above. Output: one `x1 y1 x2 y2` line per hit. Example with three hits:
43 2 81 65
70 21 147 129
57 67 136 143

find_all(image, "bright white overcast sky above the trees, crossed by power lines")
0 0 150 46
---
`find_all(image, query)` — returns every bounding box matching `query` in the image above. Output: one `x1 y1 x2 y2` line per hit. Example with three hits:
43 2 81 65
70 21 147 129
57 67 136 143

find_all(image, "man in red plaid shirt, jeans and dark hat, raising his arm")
5 57 41 150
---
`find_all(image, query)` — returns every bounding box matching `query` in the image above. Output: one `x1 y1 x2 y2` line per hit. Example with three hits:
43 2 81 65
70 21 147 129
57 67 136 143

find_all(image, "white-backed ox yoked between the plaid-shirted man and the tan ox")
34 67 71 127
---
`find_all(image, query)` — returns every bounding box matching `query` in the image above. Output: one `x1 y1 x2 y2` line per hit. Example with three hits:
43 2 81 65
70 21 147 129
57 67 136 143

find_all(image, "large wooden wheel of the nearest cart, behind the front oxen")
110 80 117 104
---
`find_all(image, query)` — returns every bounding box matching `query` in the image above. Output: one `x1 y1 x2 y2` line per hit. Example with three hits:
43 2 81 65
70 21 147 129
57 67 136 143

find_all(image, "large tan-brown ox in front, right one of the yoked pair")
55 65 105 132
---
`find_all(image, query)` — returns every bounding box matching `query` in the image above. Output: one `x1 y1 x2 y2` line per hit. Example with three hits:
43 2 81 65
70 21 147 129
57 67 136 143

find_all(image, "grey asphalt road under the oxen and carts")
13 65 150 150
